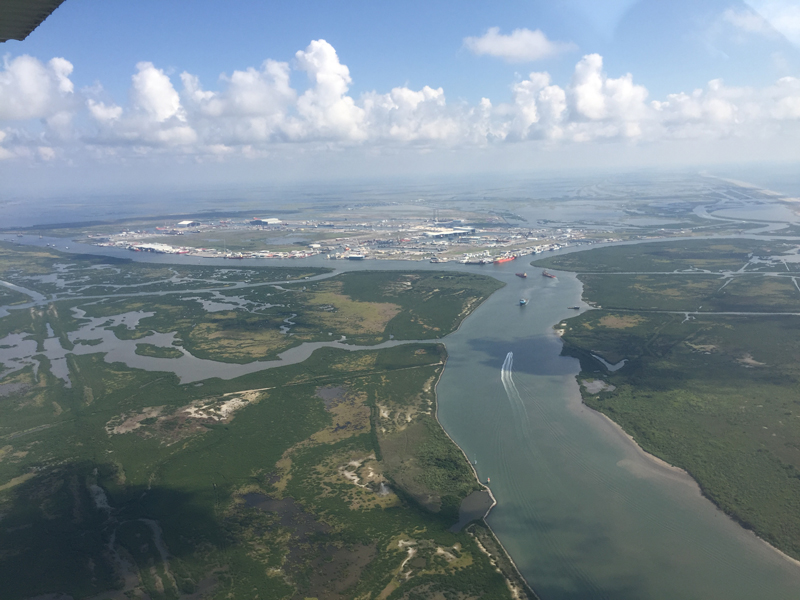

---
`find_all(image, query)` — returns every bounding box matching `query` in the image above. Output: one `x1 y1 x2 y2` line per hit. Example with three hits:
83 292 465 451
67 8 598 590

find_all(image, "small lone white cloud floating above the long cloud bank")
464 27 577 62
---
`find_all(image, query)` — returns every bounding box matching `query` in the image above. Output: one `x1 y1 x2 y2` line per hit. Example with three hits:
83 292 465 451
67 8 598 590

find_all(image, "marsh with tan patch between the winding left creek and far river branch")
0 244 501 363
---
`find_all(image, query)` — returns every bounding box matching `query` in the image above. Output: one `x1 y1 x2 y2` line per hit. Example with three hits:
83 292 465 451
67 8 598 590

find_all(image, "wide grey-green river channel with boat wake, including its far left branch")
6 237 800 600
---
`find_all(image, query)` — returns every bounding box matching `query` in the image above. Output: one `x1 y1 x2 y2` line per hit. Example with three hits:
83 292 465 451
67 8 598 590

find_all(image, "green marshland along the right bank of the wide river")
534 239 800 558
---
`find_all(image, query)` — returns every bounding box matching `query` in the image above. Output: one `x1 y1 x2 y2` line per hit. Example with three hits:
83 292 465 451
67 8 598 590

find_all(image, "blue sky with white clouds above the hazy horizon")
0 0 800 197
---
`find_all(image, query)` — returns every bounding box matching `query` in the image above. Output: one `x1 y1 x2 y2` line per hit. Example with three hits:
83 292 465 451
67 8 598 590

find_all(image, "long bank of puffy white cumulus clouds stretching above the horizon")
0 39 800 161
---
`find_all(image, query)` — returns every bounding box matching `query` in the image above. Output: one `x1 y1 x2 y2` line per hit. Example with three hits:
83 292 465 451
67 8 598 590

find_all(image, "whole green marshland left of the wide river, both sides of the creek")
0 247 533 600
